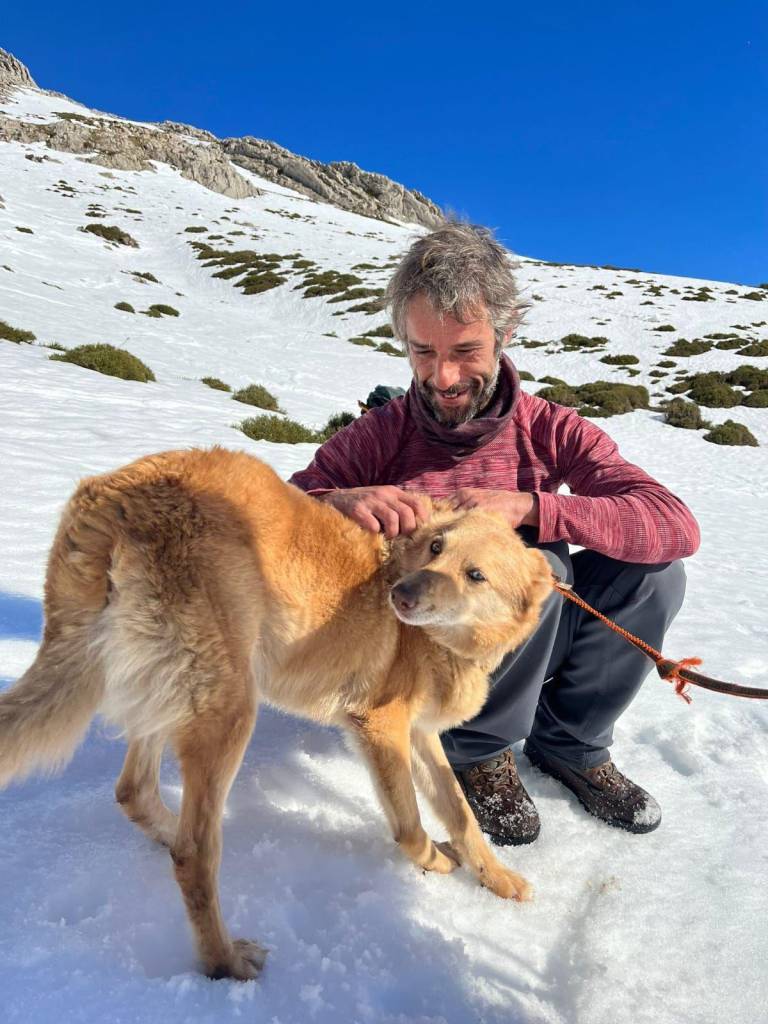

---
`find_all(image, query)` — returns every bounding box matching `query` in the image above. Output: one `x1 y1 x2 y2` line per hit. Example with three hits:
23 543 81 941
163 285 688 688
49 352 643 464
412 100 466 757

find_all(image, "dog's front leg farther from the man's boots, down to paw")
352 701 458 874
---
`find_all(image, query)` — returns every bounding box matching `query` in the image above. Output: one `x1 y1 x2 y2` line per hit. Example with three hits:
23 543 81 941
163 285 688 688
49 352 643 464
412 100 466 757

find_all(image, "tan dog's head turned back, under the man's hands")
390 505 552 649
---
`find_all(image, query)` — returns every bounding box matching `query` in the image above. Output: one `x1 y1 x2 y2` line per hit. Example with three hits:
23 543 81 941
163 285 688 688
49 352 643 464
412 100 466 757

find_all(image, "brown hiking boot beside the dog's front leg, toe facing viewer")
456 751 541 846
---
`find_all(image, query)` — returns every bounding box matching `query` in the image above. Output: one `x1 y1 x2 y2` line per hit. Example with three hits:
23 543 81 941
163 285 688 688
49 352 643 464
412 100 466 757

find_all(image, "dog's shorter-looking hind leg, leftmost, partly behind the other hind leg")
115 734 178 847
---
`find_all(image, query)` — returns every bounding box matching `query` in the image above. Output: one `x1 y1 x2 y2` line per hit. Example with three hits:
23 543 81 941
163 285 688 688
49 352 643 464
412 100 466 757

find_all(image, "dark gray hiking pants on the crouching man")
442 529 685 768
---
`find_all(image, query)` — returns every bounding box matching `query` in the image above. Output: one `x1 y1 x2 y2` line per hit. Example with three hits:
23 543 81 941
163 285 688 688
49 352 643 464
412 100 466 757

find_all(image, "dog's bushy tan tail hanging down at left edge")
0 487 114 788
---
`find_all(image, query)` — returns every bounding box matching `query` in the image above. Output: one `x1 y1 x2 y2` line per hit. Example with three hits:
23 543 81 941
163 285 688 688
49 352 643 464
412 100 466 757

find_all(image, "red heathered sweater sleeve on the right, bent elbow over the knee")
539 407 699 564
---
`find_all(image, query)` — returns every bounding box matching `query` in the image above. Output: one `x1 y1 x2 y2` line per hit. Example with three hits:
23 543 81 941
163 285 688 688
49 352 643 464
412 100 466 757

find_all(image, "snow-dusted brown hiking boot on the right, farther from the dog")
523 739 662 833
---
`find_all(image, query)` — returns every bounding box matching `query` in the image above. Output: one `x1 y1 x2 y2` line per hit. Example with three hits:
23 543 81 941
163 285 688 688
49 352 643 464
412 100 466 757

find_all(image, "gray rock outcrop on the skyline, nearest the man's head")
221 135 443 227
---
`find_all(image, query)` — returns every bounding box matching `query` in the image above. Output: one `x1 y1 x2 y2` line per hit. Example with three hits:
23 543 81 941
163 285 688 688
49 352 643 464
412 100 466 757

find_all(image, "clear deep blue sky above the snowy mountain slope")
0 0 768 284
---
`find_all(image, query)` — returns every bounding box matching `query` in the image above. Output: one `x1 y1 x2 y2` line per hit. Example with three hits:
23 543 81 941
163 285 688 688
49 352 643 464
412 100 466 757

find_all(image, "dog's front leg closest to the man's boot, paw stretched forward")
412 729 532 900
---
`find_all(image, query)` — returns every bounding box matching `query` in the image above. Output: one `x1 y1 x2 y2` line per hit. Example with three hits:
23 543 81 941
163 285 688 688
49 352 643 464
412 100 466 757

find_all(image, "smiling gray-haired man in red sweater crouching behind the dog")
291 223 698 845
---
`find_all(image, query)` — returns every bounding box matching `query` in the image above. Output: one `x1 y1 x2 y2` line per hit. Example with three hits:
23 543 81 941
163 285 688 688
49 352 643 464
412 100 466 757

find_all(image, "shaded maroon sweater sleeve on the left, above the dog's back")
288 399 402 498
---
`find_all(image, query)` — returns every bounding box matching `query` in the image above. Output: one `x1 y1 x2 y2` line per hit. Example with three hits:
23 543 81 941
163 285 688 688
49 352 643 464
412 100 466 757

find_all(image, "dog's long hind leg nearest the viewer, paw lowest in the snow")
171 691 266 981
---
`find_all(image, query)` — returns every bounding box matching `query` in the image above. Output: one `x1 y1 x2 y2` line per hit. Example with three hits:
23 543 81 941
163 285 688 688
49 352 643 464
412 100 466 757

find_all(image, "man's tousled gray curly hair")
386 220 527 352
